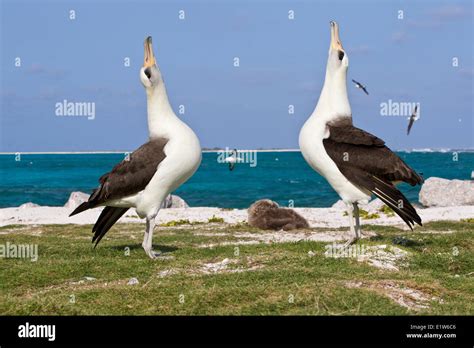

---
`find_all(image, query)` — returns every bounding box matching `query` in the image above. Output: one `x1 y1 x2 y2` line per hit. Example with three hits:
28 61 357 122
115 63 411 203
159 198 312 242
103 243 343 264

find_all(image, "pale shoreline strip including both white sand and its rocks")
0 177 474 228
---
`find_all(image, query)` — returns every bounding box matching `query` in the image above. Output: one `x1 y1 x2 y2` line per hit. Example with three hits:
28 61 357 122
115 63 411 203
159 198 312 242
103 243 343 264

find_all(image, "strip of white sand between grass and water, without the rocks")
0 206 474 229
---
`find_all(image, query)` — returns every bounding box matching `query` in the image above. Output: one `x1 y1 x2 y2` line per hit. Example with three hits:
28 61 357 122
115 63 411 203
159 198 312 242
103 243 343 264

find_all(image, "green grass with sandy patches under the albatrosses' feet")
0 221 474 315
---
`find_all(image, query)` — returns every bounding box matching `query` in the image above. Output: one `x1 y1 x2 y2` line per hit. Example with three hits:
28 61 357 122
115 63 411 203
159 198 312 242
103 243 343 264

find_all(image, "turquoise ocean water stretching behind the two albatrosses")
0 152 474 208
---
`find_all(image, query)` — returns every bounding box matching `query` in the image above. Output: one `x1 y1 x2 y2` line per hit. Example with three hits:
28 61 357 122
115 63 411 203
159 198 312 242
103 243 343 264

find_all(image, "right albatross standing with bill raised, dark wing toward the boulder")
299 22 423 245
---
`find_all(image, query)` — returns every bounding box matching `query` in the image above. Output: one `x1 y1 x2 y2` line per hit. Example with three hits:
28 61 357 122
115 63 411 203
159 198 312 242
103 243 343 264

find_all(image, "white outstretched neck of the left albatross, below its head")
146 82 181 138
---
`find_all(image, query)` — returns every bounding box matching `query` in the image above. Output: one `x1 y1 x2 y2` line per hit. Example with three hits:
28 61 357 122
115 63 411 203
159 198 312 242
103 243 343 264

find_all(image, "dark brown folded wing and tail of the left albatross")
69 139 167 246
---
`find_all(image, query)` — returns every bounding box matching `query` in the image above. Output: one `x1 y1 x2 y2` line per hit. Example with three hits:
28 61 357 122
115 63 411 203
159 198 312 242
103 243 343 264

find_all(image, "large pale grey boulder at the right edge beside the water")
419 177 474 207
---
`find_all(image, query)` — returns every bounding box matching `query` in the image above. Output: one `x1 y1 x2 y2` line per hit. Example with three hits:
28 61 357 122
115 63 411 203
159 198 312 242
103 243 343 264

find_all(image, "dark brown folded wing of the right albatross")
323 125 423 228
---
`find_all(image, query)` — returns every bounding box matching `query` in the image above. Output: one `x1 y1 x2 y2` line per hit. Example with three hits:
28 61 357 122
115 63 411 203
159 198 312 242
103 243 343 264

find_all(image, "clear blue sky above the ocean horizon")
0 0 474 152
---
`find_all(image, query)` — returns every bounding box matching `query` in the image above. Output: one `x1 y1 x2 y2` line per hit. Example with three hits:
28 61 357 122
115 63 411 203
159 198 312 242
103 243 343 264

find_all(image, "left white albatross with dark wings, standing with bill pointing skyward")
70 37 201 258
